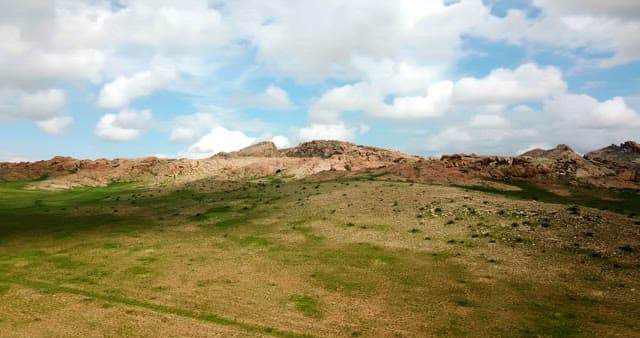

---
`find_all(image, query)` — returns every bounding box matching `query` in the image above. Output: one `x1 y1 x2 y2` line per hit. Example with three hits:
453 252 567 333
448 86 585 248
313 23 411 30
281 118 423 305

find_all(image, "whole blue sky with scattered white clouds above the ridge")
0 0 640 161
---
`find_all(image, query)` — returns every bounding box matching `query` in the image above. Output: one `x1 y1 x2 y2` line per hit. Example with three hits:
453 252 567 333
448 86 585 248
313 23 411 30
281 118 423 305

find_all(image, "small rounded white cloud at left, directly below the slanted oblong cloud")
96 109 153 142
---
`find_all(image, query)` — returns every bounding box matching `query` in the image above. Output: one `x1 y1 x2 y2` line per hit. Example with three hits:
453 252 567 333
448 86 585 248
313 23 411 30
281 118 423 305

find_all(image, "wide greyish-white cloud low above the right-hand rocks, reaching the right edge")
422 93 640 155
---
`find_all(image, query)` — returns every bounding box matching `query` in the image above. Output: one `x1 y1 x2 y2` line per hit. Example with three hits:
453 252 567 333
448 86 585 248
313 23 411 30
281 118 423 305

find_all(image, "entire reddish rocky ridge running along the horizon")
0 141 640 189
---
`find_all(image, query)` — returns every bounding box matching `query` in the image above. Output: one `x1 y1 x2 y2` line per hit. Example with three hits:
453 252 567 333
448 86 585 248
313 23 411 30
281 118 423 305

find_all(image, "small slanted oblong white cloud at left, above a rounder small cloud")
98 69 177 108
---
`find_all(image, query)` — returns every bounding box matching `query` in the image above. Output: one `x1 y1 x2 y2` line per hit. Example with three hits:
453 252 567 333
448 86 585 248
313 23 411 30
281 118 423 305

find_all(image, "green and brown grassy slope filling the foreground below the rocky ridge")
0 177 640 337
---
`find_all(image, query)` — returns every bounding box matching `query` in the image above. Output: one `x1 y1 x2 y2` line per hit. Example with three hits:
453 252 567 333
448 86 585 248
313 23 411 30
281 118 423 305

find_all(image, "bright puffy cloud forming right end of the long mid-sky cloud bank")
454 63 567 104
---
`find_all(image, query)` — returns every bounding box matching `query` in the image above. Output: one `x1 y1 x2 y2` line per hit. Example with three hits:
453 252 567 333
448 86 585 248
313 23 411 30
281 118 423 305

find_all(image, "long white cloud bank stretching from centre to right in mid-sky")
309 63 567 124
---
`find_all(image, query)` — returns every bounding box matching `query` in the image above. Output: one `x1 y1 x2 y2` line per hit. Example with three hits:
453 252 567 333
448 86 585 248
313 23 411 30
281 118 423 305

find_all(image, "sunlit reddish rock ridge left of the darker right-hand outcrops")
0 141 418 187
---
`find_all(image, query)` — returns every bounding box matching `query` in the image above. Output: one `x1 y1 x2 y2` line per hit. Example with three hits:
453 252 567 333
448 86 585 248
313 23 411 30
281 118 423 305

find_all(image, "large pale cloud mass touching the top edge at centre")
227 0 489 81
